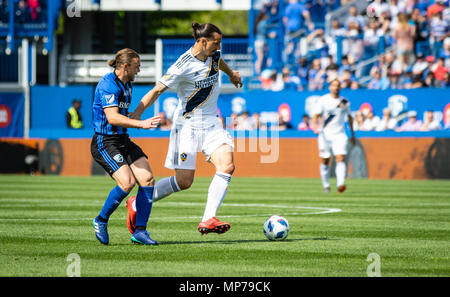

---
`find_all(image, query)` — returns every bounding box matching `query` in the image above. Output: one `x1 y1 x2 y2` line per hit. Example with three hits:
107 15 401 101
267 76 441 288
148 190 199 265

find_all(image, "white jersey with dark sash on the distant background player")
314 94 350 135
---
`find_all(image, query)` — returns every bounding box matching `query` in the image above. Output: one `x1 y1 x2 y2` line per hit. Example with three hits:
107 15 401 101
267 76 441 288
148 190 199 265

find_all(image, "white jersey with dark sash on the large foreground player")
160 48 221 126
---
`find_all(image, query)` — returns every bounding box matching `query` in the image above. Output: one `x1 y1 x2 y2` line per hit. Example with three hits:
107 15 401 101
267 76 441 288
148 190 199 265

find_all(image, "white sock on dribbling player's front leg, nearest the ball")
202 172 231 222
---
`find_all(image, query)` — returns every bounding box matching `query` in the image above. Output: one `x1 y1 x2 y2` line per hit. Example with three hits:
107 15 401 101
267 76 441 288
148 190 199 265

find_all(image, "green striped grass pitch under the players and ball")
0 175 450 277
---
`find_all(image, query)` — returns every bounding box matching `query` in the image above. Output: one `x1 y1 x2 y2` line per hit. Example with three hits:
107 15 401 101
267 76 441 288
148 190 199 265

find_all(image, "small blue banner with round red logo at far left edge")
0 93 24 137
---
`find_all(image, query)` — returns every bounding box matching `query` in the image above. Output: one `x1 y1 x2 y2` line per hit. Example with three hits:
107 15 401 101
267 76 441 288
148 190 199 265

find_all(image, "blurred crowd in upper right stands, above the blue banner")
254 0 450 91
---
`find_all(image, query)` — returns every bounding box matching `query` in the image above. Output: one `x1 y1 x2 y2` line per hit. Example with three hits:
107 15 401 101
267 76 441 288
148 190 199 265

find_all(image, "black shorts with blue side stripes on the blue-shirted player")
91 133 148 176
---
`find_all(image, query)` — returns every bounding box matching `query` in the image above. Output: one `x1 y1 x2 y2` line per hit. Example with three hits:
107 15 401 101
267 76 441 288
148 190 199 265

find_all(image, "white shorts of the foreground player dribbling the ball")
165 121 234 170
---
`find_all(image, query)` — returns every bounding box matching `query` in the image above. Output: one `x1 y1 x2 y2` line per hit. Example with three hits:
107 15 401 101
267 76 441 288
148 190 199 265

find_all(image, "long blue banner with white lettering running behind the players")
30 85 450 138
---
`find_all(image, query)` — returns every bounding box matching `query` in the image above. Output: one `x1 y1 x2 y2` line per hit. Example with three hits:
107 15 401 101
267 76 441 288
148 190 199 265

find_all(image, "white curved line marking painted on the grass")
0 201 342 221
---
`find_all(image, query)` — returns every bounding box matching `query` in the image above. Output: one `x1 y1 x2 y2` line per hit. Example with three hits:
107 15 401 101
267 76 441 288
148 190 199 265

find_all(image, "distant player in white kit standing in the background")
312 79 355 193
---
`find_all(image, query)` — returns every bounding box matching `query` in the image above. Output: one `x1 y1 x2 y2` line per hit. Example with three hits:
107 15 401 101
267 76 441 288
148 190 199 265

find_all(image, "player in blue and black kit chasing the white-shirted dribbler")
91 48 159 245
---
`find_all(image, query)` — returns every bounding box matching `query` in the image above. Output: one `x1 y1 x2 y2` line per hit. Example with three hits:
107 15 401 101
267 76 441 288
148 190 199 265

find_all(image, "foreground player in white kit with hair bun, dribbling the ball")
127 22 242 234
